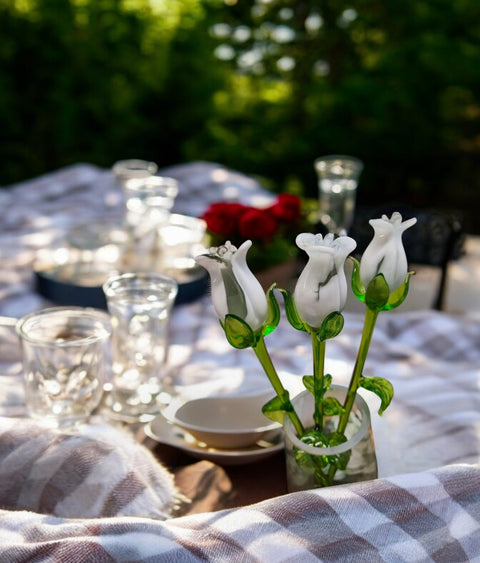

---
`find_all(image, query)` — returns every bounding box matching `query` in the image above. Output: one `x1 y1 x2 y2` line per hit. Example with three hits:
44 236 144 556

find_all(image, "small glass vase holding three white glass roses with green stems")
285 385 378 492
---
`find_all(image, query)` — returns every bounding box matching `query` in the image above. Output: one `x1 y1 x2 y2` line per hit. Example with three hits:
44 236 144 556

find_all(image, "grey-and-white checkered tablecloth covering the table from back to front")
0 163 480 563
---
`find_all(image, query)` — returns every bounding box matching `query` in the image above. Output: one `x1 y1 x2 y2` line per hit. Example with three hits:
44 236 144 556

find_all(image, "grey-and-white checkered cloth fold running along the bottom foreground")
0 465 480 563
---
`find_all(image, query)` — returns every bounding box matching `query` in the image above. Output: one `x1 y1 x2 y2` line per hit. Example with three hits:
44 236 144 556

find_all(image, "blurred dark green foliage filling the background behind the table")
0 0 480 230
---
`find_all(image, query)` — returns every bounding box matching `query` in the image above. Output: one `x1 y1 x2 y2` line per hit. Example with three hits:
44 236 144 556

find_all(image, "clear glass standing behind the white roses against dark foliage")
314 155 363 235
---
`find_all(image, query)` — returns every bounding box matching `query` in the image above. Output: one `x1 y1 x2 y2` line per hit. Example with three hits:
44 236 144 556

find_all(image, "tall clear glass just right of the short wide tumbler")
103 273 178 422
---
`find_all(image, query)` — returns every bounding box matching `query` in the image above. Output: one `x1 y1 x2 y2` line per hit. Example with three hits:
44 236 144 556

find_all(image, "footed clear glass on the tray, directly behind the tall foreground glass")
123 176 178 271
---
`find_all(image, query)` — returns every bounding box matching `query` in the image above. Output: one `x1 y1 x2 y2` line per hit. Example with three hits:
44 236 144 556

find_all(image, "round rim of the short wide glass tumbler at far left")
15 306 112 348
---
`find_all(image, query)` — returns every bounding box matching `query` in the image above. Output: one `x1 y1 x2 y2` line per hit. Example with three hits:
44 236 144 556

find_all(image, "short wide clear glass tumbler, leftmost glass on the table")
16 307 111 430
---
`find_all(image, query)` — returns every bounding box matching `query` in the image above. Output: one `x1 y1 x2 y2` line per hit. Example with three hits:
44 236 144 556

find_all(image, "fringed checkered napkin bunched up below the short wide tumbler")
0 418 184 519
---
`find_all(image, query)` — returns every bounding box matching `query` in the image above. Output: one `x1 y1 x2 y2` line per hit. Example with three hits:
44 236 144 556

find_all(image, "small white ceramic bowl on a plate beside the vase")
164 393 281 450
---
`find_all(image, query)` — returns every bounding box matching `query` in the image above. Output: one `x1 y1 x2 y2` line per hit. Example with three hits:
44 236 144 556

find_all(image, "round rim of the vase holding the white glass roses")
284 384 371 456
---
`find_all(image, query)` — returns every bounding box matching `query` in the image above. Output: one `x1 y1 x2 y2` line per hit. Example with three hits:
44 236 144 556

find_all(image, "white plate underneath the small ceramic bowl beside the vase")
145 414 284 465
